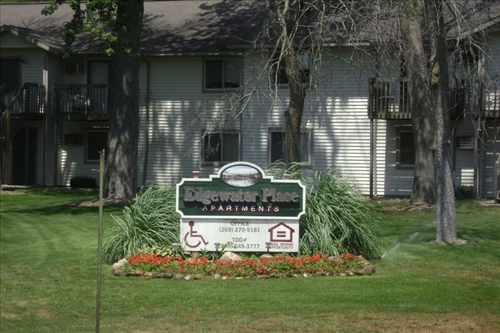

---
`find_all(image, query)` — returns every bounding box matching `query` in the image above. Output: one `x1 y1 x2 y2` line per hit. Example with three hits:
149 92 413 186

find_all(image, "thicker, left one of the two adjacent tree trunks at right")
400 3 436 204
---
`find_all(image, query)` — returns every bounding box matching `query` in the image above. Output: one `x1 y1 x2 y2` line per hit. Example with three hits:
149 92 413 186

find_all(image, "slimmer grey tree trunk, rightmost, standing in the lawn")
425 0 458 244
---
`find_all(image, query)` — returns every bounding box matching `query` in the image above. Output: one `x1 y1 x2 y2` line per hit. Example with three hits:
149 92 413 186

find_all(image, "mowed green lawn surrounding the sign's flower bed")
0 189 500 333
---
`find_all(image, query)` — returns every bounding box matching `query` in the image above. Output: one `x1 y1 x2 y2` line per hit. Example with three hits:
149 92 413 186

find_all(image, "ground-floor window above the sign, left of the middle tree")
203 132 240 163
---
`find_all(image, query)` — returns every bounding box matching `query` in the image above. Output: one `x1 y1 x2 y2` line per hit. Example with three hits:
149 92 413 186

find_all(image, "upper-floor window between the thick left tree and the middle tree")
204 59 241 90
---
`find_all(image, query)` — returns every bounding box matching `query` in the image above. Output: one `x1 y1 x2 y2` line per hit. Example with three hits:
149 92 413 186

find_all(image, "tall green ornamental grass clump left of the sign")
102 185 180 264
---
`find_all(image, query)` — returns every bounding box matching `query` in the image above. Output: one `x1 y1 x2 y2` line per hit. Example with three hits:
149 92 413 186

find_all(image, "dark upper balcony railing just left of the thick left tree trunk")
52 84 109 120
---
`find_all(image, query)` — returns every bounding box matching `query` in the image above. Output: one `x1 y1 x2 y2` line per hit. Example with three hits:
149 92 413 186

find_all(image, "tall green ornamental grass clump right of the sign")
300 170 383 259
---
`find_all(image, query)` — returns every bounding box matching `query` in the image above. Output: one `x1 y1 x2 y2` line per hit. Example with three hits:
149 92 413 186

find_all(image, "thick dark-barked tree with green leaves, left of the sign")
44 0 144 198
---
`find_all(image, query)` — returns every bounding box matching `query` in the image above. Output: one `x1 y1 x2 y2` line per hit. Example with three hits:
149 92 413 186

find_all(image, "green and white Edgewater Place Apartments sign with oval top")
176 162 306 252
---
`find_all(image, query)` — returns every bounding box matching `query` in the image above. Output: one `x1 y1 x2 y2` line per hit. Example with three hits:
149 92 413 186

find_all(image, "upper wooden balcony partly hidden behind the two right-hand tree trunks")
368 77 464 119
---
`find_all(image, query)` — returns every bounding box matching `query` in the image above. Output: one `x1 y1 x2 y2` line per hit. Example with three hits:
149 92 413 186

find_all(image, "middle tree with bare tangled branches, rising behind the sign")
257 0 341 173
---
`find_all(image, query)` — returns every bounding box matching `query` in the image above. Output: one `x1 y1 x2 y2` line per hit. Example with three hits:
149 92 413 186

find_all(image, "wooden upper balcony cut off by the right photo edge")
475 75 500 119
